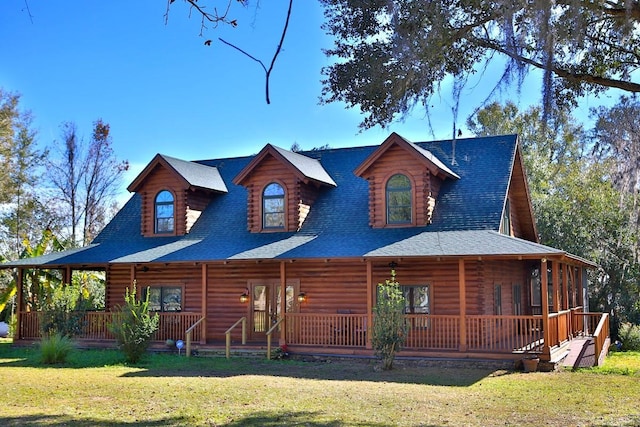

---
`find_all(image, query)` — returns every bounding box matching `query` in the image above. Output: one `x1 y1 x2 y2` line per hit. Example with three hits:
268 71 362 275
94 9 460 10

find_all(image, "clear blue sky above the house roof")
0 0 620 193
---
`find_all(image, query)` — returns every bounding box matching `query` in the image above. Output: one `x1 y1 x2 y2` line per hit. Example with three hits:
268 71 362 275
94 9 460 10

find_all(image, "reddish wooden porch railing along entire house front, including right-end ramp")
16 307 609 364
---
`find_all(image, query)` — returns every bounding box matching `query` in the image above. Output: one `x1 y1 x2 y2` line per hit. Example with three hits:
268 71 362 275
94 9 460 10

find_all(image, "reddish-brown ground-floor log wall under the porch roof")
106 259 528 341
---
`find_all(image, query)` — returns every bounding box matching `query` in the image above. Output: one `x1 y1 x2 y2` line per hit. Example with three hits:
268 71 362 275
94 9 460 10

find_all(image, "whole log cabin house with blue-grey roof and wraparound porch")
2 133 609 362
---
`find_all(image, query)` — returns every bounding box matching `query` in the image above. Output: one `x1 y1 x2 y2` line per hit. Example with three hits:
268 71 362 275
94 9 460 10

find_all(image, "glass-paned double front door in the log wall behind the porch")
249 282 295 341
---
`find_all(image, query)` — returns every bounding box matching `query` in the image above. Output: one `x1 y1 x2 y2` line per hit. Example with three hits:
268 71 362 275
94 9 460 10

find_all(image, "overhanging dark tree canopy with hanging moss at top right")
321 0 640 128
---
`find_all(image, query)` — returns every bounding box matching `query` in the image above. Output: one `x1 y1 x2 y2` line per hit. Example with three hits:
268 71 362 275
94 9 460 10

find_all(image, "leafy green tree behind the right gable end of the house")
468 104 640 331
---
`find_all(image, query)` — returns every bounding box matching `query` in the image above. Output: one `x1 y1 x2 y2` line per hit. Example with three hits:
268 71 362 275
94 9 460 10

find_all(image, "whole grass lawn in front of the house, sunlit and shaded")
0 342 640 427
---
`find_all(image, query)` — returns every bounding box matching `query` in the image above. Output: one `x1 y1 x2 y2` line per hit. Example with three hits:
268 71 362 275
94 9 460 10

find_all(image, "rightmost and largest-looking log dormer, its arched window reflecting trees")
354 132 460 228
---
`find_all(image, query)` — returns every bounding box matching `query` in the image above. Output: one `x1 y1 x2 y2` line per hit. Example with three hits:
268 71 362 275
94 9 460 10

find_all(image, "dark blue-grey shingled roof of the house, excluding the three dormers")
0 135 596 266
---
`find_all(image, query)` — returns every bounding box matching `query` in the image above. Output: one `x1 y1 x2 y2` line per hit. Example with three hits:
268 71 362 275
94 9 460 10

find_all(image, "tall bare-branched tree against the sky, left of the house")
49 120 129 246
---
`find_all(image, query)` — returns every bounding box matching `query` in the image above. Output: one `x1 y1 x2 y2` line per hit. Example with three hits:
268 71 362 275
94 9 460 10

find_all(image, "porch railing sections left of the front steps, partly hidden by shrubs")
19 311 204 342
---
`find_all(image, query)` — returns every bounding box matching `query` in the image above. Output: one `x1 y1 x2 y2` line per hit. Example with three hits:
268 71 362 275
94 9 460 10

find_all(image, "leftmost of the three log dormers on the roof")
127 154 227 237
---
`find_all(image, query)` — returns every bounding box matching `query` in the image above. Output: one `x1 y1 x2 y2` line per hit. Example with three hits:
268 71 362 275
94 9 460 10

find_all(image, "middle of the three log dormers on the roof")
233 144 336 233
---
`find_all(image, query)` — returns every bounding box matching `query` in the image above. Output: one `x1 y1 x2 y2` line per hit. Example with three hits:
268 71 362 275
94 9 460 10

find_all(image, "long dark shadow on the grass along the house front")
0 343 508 388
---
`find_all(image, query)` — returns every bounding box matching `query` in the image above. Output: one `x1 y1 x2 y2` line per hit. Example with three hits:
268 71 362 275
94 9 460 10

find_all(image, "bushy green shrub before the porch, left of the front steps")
107 284 160 363
